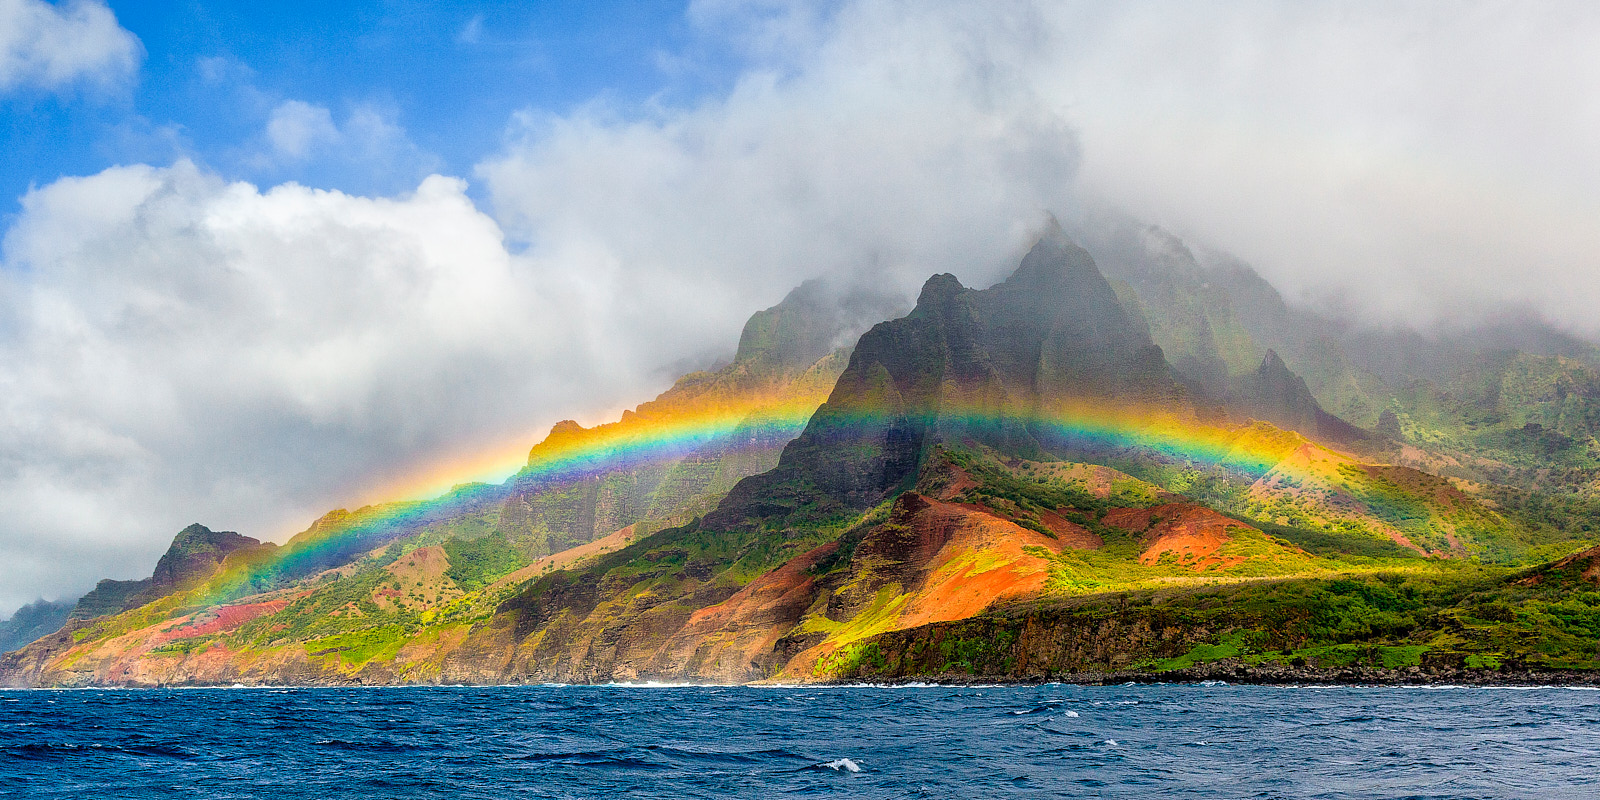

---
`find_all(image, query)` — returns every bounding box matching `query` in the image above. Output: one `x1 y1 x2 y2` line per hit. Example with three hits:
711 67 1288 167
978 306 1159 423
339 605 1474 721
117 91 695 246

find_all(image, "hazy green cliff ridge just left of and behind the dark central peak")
496 282 890 557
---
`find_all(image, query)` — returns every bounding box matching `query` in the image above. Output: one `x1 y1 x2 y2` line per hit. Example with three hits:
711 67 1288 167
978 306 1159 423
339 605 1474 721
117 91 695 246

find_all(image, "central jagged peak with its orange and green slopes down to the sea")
444 228 1542 680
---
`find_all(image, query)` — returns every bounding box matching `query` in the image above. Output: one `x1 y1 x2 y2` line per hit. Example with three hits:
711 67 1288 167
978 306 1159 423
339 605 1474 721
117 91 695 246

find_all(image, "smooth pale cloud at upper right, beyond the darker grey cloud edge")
1030 2 1600 334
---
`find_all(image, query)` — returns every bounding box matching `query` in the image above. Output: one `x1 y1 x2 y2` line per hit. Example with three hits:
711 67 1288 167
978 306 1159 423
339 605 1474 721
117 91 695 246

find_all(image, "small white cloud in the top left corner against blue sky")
0 0 144 91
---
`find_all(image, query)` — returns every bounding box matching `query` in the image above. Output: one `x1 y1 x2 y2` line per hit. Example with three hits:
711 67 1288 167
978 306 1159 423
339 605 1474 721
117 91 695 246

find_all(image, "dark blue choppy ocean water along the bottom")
0 685 1600 800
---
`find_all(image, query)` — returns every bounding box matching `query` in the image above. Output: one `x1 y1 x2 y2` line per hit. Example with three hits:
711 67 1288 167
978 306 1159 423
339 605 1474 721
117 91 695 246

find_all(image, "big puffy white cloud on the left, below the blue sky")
0 163 637 608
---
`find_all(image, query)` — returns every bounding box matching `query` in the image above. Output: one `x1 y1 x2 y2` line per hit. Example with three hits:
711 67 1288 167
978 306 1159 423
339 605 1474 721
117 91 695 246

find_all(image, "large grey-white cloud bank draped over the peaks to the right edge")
480 0 1600 334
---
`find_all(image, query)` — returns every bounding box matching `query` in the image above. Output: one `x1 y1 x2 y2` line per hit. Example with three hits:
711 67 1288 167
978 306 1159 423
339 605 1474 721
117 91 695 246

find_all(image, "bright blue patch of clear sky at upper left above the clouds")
0 0 734 211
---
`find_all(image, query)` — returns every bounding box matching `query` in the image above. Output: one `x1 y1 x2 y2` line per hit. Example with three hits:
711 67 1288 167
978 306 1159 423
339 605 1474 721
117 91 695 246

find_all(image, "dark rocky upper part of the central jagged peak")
704 229 1187 528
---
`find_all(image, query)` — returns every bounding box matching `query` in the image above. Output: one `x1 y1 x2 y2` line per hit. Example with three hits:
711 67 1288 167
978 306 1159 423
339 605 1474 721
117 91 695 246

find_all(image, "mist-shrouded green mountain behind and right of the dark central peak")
1075 213 1600 533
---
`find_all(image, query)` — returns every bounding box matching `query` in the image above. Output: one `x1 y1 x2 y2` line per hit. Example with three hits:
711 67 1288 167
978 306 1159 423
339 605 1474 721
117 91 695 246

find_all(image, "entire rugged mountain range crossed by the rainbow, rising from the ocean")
0 227 1600 685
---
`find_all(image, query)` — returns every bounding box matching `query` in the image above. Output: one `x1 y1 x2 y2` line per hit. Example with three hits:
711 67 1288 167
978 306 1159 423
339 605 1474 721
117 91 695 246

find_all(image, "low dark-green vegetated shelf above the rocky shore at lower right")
819 550 1600 677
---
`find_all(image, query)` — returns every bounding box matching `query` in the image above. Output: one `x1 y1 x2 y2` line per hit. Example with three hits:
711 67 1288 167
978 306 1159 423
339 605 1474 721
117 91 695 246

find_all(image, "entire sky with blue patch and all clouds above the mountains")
0 0 1600 613
